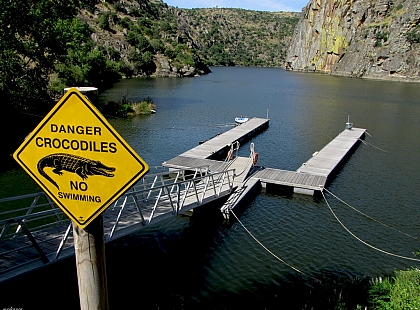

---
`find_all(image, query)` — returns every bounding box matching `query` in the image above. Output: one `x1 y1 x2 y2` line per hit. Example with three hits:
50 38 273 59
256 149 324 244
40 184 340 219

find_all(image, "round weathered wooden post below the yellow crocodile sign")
73 214 109 310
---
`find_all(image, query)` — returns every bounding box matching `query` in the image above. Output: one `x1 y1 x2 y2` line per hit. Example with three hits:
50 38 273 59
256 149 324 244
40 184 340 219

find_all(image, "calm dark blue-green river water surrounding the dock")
2 67 420 309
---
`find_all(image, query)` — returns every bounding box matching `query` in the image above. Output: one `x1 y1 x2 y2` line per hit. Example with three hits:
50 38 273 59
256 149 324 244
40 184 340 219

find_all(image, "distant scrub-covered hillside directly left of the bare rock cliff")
174 8 299 67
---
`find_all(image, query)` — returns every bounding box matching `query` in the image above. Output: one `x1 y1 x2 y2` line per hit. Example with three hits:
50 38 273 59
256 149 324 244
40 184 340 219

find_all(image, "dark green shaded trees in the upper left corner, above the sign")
0 0 98 111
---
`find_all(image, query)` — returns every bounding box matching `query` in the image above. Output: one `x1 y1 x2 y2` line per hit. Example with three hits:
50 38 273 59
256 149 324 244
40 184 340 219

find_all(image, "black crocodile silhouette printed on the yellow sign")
37 153 115 189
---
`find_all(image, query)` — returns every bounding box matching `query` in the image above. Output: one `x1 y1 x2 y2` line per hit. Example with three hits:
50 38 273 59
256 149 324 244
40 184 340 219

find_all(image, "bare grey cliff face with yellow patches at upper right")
285 0 420 82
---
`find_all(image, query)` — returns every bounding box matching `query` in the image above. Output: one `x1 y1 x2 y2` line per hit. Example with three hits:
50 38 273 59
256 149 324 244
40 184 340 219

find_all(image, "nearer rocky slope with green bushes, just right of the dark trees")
79 0 209 77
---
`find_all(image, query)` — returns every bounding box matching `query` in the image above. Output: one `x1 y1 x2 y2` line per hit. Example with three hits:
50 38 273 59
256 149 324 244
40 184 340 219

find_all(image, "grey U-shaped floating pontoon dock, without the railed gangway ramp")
162 118 366 195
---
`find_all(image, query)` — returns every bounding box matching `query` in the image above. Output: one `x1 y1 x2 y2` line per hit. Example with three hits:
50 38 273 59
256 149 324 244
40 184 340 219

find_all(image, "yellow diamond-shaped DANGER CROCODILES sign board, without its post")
13 88 149 228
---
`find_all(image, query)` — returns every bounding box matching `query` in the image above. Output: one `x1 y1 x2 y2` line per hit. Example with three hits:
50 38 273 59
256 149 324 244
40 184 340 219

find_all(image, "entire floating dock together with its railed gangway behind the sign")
0 118 366 281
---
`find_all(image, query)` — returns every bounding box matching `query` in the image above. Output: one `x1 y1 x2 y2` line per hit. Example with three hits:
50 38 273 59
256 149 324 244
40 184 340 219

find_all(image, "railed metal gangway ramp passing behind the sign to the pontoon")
0 167 235 282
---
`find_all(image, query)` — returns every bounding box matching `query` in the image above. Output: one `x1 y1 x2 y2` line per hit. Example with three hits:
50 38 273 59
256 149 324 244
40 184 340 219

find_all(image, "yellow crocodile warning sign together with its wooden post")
13 88 149 310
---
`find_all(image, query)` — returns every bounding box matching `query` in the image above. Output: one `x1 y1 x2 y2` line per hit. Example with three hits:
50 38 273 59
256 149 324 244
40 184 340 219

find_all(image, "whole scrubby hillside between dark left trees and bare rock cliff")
79 0 299 77
